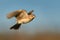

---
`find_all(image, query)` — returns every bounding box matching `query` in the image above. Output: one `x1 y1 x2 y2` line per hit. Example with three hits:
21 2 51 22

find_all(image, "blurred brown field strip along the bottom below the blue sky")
0 32 60 40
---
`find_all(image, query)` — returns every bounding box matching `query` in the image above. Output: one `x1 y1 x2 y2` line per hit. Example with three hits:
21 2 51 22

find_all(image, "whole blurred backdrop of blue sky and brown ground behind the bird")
0 0 60 40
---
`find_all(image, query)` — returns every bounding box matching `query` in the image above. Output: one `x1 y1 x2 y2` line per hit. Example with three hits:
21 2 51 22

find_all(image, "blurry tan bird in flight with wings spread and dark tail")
7 9 36 30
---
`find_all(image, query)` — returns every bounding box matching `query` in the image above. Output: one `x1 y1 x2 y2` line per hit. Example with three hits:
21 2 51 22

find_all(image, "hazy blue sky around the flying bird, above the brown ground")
0 0 60 32
